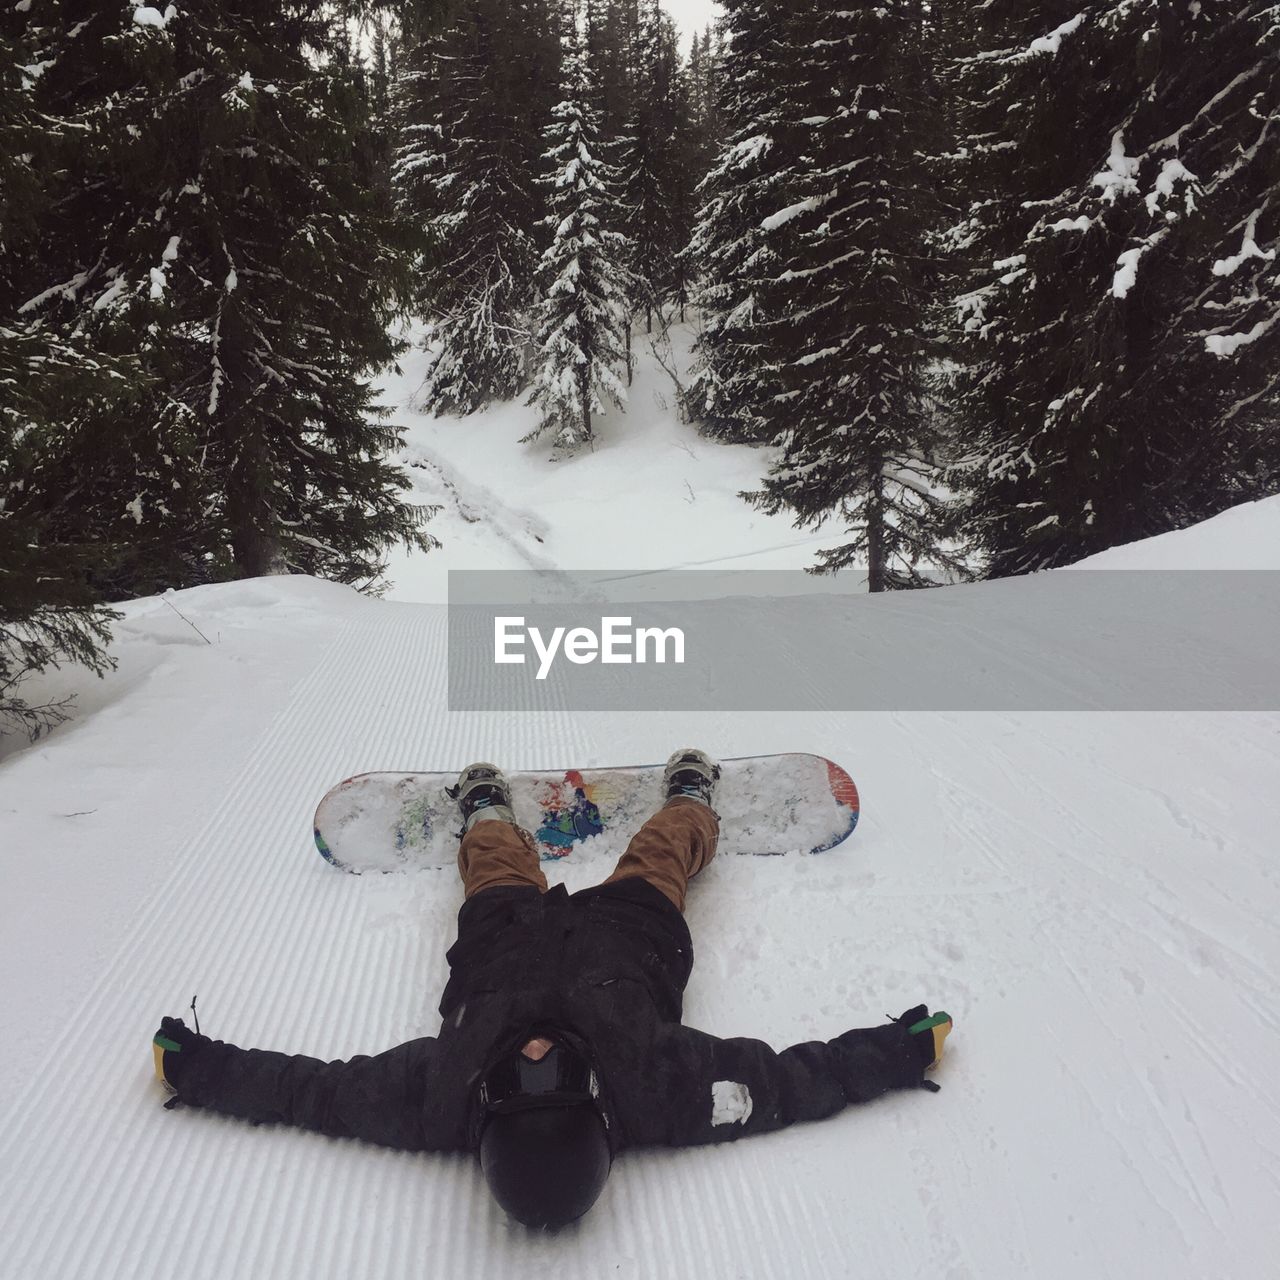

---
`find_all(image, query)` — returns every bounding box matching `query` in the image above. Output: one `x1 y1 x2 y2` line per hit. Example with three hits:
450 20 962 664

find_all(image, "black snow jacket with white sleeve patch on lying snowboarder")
170 879 924 1152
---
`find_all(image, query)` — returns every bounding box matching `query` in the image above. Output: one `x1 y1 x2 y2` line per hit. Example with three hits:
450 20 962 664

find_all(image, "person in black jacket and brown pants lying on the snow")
154 750 951 1228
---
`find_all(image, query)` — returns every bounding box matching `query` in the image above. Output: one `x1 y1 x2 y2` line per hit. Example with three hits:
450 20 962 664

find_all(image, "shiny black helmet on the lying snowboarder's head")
480 1043 612 1229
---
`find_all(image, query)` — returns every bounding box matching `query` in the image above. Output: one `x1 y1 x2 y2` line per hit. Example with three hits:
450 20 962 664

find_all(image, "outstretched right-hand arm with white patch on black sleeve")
660 1009 950 1146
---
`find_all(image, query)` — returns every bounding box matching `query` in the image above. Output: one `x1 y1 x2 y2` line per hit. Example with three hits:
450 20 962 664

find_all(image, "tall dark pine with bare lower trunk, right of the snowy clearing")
751 0 955 591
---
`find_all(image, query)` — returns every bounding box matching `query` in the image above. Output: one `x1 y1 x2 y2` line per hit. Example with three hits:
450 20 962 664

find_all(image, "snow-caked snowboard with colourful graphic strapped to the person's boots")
315 753 859 874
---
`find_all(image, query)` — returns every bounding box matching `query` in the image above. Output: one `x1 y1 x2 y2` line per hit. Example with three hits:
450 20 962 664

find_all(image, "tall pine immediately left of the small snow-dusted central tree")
396 0 559 413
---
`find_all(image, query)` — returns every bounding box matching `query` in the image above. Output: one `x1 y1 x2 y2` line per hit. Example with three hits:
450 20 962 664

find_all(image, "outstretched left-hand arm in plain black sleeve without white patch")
155 1018 439 1151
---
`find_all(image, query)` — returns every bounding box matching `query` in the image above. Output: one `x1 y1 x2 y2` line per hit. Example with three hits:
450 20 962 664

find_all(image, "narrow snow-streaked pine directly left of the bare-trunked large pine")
686 0 794 440
